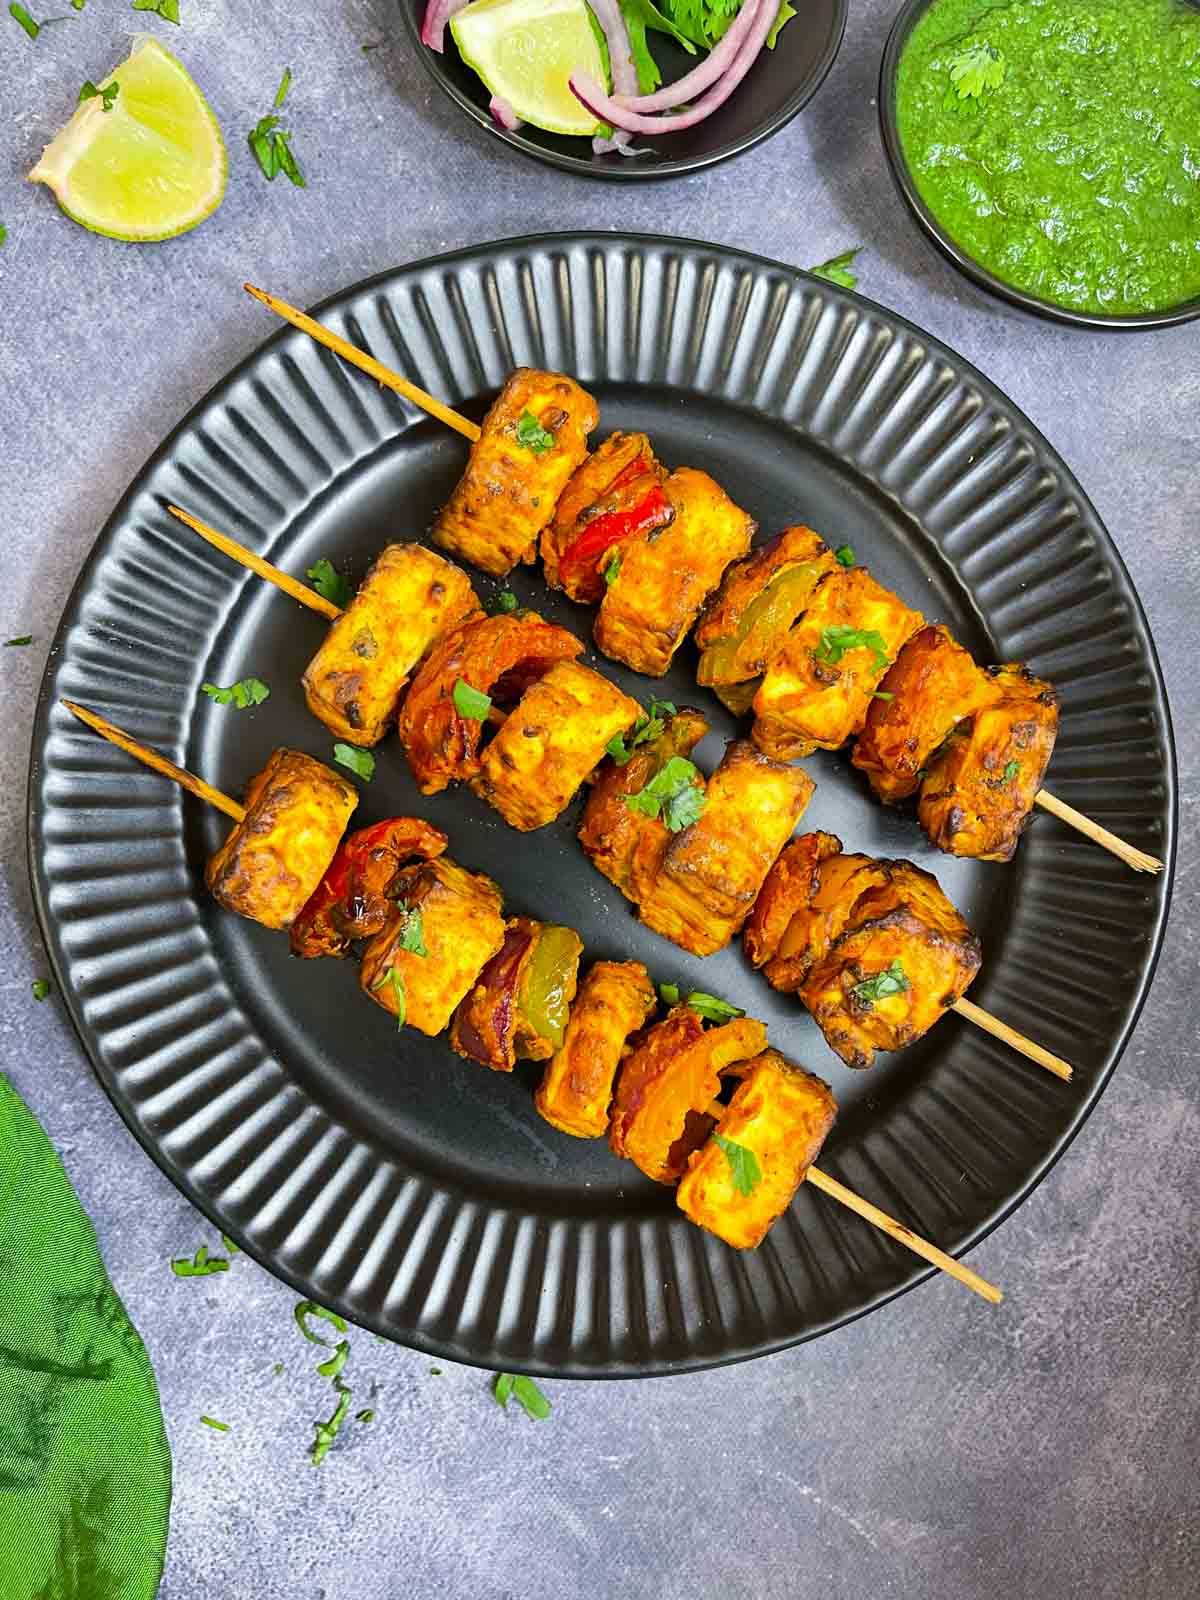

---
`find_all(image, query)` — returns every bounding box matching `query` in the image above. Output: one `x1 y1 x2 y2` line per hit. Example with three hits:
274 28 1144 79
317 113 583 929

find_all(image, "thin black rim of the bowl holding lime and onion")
398 0 850 182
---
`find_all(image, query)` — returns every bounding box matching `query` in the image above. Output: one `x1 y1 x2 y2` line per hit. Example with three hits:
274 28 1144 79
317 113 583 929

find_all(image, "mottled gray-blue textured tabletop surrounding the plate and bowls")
0 0 1200 1600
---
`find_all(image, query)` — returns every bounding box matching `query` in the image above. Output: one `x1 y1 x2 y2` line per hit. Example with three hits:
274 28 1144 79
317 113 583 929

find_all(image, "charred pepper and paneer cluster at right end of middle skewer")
746 834 981 1067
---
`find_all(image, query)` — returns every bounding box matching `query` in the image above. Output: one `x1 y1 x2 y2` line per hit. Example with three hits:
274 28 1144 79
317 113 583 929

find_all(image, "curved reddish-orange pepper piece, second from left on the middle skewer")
398 611 584 795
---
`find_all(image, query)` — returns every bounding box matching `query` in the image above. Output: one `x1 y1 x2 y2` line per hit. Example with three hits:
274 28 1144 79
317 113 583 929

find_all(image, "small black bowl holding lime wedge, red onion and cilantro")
400 0 848 181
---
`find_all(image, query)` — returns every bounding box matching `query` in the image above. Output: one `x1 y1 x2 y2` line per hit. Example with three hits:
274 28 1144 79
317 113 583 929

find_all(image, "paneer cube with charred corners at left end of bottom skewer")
205 749 358 928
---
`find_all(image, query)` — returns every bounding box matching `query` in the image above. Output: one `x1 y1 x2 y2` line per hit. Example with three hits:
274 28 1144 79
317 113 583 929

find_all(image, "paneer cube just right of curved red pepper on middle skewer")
470 661 642 832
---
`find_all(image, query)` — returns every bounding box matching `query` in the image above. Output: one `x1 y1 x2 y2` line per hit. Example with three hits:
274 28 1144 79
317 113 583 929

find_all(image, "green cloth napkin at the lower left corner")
0 1074 171 1600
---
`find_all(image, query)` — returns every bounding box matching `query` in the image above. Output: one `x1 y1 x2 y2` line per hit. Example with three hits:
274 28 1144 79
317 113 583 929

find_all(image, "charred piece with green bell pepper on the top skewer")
696 526 838 697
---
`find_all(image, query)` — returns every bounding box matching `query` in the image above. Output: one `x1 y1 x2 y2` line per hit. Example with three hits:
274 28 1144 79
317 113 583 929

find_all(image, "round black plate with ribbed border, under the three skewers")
30 234 1174 1376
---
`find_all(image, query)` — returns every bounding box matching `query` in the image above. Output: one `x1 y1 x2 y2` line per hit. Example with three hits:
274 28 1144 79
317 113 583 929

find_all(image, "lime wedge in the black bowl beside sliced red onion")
450 0 608 134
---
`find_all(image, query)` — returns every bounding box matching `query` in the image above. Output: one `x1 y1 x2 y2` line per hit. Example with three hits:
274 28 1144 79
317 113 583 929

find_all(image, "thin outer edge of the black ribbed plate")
26 229 1179 1381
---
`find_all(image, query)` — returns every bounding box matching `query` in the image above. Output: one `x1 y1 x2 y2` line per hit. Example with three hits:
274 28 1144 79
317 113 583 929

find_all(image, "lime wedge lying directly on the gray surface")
29 38 229 240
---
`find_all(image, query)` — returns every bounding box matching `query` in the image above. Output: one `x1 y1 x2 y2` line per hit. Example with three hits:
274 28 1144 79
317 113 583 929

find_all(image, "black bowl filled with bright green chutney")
878 0 1200 328
